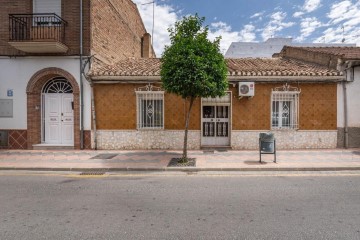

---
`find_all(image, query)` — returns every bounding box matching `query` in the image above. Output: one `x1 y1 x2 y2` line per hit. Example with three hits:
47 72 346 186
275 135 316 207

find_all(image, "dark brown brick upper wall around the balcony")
0 0 90 56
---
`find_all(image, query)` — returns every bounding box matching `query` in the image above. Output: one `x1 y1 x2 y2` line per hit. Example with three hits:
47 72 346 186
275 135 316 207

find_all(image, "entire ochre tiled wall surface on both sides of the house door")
94 83 337 130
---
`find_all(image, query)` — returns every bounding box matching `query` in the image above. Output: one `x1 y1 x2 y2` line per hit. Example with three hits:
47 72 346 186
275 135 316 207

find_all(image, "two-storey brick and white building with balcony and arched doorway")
0 0 154 149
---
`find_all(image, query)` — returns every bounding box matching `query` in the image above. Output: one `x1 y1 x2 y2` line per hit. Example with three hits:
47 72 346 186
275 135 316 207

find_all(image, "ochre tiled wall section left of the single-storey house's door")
94 84 200 130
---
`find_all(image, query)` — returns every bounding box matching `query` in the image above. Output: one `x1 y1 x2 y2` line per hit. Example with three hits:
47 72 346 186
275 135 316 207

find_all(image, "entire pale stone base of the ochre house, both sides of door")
93 130 337 150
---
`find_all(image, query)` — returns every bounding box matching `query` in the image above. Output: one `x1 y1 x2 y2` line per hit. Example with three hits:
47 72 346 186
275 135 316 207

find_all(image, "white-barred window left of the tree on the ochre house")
136 85 164 129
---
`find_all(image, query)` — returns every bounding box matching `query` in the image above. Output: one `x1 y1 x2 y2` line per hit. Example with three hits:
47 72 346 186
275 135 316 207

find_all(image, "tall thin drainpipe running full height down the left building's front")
79 0 84 149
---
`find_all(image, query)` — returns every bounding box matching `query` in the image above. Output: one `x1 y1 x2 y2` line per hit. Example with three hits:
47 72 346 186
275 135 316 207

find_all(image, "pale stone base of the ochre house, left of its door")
93 130 200 150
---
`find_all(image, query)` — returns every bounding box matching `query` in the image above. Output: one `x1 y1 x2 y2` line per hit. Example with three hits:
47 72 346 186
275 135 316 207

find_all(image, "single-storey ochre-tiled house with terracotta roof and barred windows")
89 58 345 149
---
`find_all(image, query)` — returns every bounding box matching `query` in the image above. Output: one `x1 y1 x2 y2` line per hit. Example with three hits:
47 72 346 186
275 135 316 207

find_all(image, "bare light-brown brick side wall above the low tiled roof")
91 0 155 63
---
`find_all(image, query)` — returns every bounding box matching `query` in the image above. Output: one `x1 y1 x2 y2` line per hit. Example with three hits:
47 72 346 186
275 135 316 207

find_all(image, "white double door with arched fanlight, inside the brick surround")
41 77 74 146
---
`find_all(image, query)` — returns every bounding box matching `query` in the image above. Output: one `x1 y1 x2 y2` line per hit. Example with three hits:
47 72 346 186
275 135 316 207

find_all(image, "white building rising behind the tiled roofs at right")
225 38 356 58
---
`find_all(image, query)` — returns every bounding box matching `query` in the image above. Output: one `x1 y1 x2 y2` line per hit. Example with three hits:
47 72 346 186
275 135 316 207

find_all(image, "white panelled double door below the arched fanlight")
44 93 74 145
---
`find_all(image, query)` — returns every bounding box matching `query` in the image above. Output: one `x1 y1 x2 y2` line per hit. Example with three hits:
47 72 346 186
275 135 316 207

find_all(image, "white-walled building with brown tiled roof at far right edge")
280 47 360 148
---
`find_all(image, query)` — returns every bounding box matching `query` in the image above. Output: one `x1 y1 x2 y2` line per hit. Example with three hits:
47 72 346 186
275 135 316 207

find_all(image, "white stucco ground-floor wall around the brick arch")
0 57 91 130
